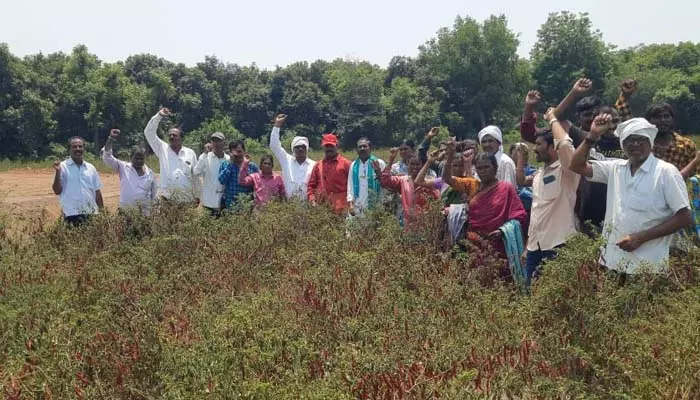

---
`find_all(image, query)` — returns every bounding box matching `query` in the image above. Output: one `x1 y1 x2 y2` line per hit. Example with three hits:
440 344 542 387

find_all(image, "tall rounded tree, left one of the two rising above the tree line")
418 15 527 136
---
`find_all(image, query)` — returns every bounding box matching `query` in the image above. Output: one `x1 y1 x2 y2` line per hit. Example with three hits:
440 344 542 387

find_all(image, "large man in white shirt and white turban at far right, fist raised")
569 114 691 274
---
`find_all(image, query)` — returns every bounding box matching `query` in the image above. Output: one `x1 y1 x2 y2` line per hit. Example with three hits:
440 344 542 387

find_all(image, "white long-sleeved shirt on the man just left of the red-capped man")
270 127 316 201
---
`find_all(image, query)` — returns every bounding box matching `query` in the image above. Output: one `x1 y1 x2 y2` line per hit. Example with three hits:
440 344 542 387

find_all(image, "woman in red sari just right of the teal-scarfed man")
372 148 440 230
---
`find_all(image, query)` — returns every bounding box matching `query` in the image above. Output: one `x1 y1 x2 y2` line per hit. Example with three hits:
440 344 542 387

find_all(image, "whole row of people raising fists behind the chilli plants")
53 79 700 286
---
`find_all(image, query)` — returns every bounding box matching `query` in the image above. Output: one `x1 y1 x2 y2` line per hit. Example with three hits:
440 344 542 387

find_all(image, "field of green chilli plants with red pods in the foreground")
0 203 700 399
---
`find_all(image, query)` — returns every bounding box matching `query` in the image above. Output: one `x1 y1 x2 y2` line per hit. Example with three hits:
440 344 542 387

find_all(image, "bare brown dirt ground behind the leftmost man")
0 169 119 220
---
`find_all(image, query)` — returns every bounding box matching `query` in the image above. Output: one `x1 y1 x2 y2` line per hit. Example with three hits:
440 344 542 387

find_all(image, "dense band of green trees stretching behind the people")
0 12 700 158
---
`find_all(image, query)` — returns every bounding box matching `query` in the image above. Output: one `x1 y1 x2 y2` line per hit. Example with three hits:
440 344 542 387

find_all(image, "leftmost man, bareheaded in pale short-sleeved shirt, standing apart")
51 136 104 226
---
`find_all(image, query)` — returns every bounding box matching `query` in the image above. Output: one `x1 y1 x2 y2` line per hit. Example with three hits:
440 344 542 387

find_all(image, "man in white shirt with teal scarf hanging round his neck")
347 137 386 215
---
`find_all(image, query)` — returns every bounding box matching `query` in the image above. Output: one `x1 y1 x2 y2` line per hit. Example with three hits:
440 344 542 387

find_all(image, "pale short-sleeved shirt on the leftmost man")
59 158 102 217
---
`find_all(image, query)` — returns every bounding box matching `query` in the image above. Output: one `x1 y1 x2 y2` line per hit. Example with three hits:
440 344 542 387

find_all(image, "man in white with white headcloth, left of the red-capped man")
270 114 316 201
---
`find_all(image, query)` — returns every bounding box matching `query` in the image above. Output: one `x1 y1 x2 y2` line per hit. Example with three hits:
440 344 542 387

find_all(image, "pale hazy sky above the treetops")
0 0 700 68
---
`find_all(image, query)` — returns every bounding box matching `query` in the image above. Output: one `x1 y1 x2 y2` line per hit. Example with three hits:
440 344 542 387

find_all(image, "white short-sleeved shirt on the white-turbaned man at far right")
589 154 690 273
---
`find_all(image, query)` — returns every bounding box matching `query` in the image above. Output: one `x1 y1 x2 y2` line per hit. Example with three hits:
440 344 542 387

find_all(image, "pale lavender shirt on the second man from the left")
102 147 157 215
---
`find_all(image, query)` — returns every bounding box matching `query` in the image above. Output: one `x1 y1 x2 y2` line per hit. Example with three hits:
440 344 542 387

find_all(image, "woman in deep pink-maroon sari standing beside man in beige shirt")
467 153 527 276
